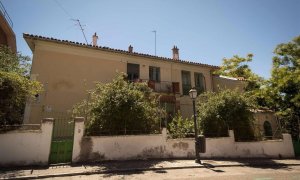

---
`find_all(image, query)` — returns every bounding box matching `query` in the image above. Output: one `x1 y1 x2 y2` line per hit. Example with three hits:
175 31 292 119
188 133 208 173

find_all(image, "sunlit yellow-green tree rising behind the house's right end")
215 54 263 91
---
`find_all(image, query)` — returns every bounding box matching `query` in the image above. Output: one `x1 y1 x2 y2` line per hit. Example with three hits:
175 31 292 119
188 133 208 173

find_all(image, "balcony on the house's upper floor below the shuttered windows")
139 79 180 94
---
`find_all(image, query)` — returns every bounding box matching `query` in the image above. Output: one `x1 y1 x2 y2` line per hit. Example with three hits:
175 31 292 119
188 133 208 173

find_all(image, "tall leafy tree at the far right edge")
266 36 300 139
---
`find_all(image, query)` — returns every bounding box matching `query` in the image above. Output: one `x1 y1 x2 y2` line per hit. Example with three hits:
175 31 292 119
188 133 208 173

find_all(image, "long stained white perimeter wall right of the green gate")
73 119 294 162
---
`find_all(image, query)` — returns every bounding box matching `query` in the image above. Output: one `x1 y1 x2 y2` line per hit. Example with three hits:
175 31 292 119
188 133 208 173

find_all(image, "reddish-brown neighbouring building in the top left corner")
0 2 17 52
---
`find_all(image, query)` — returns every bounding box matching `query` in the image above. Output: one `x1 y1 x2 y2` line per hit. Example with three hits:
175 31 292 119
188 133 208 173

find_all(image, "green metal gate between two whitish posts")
49 118 74 164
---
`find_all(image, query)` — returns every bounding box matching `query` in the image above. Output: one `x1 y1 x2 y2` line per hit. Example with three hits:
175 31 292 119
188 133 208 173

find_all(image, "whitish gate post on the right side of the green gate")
72 117 84 163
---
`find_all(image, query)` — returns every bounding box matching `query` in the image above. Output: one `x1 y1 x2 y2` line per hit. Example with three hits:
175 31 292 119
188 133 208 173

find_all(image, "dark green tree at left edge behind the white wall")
0 46 42 125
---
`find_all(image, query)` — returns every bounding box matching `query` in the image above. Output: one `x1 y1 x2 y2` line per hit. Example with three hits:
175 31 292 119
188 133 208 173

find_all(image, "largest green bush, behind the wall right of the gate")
73 74 160 135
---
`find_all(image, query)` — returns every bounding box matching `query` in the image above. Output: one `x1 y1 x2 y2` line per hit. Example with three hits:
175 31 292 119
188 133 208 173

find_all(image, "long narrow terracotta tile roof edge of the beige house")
23 33 219 69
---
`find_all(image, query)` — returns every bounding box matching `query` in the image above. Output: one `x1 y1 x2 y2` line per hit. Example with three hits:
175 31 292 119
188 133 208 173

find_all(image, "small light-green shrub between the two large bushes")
168 111 195 138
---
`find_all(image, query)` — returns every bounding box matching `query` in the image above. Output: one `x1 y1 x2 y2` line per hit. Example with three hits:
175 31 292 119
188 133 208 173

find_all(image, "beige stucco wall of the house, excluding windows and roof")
24 40 212 123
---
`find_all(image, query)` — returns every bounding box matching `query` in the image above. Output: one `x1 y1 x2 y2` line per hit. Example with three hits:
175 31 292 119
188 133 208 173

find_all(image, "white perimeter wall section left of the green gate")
0 119 53 166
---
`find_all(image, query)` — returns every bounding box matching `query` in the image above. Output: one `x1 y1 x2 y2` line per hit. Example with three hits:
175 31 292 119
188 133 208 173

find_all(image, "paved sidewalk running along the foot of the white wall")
0 159 300 179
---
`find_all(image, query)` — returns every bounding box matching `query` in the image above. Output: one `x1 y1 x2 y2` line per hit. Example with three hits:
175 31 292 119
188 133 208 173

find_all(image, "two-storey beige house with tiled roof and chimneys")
23 33 280 138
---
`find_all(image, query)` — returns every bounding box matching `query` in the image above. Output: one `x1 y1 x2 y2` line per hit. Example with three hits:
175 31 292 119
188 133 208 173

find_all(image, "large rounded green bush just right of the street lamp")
197 90 254 140
